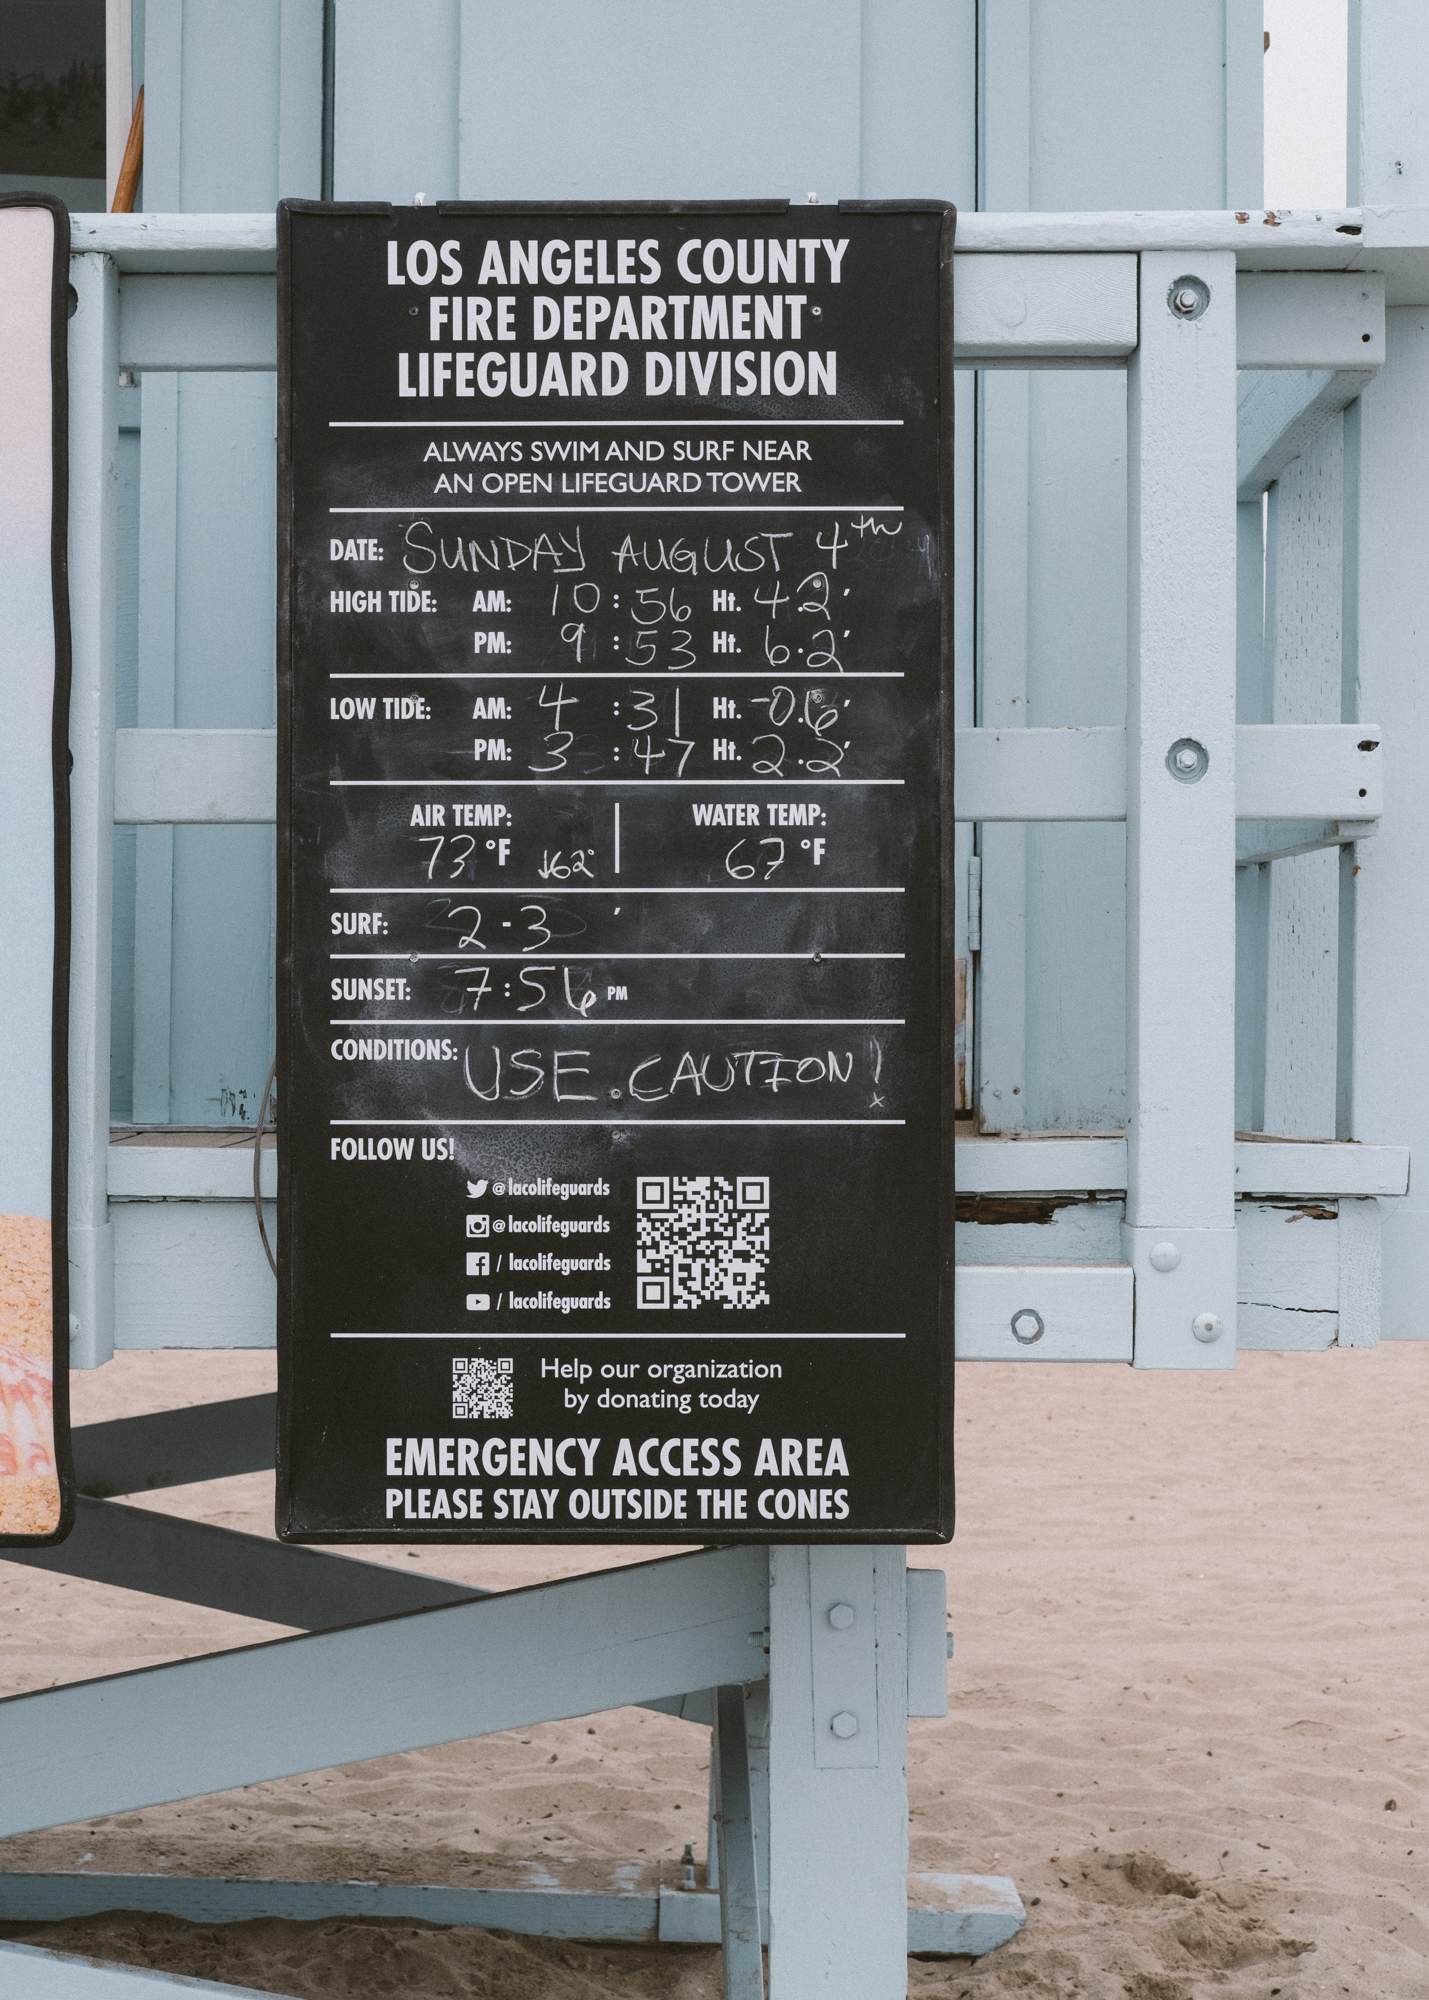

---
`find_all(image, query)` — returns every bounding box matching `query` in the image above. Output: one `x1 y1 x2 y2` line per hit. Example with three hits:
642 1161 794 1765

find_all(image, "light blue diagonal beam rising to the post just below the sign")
0 1548 769 1836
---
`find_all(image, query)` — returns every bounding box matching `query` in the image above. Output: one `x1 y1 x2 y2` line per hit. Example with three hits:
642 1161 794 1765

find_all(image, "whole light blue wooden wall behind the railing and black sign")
114 0 1261 1130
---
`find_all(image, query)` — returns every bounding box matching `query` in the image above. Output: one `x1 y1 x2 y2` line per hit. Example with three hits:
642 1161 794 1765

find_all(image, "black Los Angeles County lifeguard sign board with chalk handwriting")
278 202 953 1544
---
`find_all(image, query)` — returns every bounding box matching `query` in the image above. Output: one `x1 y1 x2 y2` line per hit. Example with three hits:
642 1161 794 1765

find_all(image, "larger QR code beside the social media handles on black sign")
634 1174 769 1312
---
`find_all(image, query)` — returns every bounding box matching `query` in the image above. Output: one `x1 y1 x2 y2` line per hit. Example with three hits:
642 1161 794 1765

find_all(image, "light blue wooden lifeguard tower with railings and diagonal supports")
0 0 1429 2000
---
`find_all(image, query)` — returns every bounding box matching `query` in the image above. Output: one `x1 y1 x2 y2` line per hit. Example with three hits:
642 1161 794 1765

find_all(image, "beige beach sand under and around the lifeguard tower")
0 1344 1429 2000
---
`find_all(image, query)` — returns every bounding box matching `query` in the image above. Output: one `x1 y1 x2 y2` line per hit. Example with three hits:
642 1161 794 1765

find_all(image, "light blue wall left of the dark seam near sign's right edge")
114 0 975 1124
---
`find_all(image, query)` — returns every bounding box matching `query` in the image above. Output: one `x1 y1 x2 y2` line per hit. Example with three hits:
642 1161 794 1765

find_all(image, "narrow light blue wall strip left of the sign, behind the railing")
114 0 322 1126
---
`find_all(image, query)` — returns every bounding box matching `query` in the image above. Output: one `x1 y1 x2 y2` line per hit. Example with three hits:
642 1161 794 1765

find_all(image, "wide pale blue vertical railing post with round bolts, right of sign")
1123 250 1237 1368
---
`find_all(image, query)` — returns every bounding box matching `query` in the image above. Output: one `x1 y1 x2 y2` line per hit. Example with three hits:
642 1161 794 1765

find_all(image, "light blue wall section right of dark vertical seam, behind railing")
979 0 1263 1132
